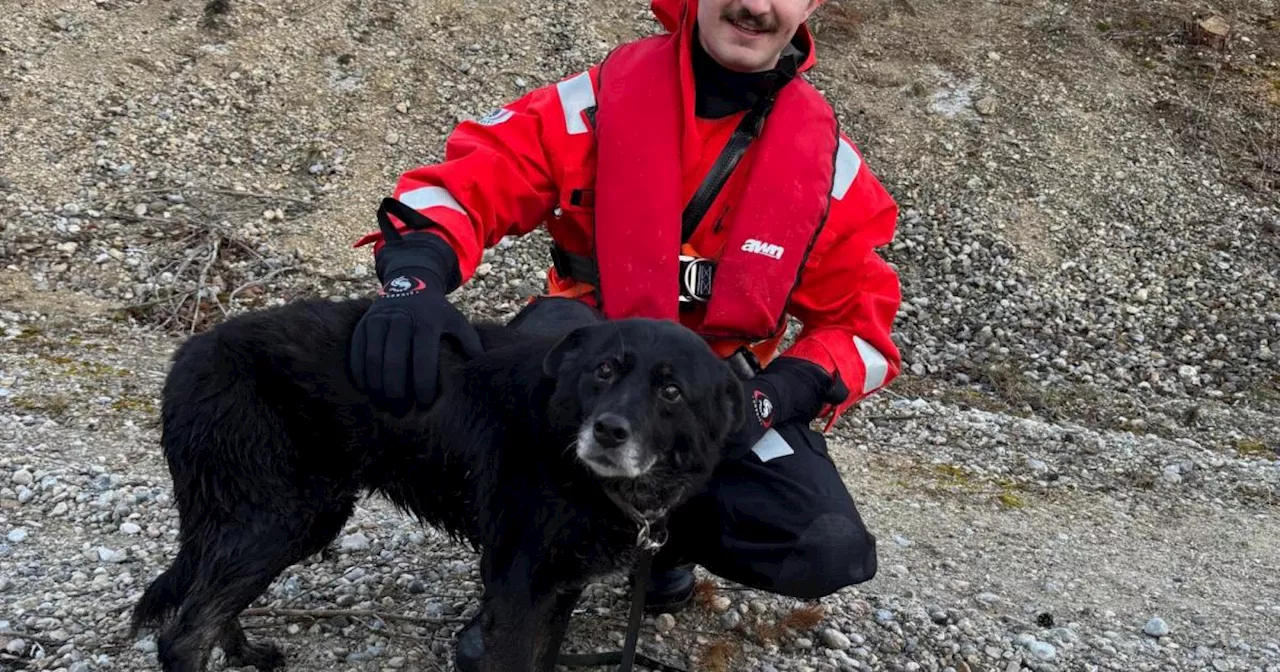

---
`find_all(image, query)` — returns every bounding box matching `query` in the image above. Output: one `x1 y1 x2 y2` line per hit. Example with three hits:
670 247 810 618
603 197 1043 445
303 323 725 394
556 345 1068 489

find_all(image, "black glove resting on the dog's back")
351 198 484 415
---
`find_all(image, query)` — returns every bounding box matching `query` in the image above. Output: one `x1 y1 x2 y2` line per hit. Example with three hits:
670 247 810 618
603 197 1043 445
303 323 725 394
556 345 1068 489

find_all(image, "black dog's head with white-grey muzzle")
543 319 744 486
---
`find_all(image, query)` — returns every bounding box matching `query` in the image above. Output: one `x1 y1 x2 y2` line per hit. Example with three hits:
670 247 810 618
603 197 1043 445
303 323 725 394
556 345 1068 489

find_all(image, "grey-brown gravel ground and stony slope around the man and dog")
0 0 1280 672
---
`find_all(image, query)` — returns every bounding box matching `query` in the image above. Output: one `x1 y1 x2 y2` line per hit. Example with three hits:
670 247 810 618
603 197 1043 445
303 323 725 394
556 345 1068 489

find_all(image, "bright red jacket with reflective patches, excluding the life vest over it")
356 0 901 429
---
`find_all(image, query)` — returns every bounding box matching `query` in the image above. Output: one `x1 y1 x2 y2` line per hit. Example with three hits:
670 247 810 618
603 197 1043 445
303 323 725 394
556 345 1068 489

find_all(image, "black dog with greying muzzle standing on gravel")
133 295 744 672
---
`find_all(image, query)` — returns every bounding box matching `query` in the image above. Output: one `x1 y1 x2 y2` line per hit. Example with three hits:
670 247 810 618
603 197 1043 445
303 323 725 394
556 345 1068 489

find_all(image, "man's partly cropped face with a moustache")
698 0 820 72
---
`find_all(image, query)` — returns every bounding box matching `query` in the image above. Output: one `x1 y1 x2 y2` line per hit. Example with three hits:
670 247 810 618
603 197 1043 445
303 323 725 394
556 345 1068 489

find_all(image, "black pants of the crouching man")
511 298 877 599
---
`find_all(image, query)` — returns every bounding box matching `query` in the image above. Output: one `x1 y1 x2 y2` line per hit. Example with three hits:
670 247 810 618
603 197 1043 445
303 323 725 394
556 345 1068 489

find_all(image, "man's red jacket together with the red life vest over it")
356 0 901 429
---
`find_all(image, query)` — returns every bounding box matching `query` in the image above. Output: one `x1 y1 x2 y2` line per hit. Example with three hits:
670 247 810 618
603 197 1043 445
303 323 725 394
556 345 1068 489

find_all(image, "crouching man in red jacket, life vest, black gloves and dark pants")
352 0 900 660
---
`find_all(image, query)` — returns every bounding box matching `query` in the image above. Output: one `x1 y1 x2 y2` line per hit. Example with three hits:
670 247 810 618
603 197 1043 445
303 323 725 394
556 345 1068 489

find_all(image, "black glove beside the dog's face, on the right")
727 356 849 460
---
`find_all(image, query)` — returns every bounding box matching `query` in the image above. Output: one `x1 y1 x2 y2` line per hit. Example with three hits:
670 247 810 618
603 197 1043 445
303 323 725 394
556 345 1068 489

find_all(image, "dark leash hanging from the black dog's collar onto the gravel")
557 492 686 672
